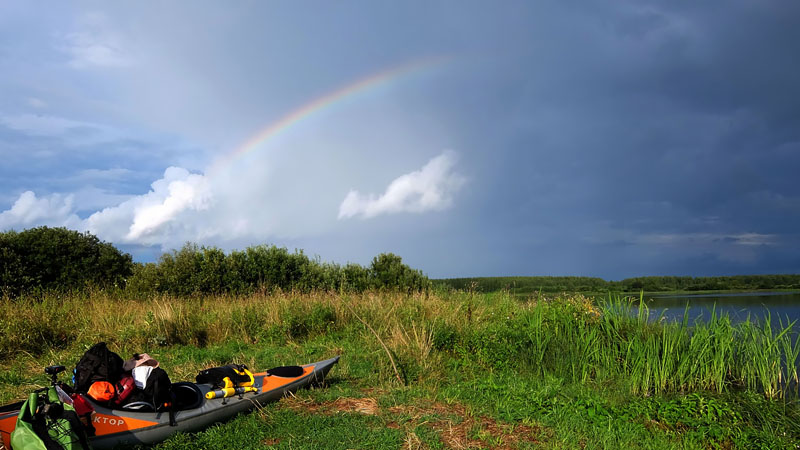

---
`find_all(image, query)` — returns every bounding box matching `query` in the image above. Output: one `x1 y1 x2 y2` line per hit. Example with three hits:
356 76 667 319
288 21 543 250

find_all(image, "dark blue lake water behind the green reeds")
645 292 800 329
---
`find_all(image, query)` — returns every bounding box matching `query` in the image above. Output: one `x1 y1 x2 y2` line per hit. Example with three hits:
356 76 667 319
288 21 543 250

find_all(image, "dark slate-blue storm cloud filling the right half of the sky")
410 2 800 277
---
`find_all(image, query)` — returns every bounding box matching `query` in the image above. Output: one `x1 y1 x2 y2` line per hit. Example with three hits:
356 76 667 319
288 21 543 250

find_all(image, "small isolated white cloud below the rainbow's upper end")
339 151 465 219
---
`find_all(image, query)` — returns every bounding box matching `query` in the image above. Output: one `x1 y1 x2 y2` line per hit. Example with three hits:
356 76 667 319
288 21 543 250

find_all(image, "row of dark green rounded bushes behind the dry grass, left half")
0 227 431 297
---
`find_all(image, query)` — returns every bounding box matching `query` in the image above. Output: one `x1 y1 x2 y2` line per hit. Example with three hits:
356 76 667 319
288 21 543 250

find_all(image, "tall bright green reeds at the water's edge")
584 298 800 398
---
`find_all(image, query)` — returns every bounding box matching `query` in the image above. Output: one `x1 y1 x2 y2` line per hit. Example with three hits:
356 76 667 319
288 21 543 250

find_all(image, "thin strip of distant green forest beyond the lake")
433 274 800 294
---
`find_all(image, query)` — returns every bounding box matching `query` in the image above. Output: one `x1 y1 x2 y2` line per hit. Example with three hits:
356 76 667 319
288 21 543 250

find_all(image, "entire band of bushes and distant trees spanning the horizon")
0 227 800 296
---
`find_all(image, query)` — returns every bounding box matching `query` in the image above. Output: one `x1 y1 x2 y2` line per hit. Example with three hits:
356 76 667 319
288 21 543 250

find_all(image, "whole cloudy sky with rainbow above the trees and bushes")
0 0 800 280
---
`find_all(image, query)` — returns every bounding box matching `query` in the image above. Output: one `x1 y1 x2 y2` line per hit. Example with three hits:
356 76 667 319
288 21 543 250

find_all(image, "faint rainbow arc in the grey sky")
209 57 450 175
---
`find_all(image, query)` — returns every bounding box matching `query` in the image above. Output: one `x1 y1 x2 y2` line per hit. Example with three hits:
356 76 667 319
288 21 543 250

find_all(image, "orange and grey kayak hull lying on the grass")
0 356 339 449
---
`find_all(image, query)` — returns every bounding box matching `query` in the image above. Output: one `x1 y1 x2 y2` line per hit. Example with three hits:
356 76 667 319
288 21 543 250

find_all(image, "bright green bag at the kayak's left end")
11 387 90 450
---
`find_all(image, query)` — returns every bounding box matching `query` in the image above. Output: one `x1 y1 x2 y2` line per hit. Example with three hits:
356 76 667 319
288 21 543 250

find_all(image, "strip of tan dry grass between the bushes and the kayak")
0 291 460 360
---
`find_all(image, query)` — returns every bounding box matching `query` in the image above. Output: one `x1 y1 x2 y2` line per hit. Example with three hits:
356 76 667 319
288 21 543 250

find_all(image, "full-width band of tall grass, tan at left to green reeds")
0 291 800 398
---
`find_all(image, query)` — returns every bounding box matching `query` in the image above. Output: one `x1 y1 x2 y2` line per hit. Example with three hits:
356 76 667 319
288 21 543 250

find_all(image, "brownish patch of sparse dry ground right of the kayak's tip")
282 397 546 449
